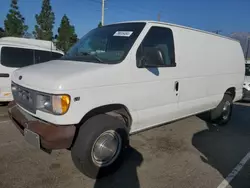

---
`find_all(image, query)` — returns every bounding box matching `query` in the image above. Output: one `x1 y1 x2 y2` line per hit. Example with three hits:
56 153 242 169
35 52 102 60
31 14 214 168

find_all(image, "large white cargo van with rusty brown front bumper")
9 21 245 178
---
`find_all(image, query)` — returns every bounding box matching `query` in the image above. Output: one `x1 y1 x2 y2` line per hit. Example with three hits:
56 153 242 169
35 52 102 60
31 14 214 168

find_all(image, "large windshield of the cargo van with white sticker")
61 23 145 64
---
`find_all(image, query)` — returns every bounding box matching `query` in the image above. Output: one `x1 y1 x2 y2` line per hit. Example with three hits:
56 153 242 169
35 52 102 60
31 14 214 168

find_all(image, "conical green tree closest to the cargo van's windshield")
56 15 78 52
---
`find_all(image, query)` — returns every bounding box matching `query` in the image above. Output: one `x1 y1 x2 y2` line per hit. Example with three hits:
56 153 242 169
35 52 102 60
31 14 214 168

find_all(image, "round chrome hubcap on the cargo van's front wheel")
91 130 121 167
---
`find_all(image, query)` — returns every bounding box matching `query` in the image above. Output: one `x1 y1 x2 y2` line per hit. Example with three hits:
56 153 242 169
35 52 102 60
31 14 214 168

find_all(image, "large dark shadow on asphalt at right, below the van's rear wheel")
192 104 250 188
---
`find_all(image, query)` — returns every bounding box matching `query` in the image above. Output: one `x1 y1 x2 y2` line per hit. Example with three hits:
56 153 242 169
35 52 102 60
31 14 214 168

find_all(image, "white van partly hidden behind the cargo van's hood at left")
0 37 63 103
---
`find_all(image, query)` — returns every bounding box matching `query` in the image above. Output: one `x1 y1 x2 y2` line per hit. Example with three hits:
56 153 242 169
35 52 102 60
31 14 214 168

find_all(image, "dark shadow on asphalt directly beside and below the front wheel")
94 147 143 188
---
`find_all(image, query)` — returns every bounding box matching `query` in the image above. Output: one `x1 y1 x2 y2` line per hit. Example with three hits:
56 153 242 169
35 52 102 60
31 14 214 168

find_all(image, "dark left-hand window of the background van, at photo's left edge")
1 47 34 68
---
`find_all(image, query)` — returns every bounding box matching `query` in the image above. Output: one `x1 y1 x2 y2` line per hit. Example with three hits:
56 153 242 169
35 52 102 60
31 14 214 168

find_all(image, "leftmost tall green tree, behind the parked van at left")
4 0 28 37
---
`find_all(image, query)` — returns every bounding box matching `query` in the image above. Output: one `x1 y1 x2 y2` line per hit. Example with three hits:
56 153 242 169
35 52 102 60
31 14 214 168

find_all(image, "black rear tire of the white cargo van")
211 94 233 126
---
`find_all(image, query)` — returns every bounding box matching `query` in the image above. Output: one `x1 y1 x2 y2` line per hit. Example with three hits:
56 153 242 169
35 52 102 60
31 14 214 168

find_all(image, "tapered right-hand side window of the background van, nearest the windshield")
35 50 62 63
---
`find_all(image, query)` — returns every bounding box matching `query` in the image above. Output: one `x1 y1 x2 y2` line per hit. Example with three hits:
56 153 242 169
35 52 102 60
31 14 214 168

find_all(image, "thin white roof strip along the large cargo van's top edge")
110 20 239 42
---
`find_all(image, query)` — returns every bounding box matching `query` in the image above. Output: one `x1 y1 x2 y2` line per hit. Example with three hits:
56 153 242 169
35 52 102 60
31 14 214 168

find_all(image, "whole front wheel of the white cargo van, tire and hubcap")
71 114 129 179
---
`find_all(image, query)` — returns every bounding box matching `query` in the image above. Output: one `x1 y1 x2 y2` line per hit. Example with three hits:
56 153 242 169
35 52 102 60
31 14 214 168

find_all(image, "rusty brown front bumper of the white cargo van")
8 101 75 150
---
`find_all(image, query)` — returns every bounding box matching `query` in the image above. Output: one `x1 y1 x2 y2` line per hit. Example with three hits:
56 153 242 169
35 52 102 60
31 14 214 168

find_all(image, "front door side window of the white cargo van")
136 26 176 67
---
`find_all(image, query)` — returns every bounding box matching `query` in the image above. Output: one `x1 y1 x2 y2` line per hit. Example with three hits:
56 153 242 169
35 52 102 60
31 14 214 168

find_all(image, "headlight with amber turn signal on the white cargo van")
36 94 70 115
